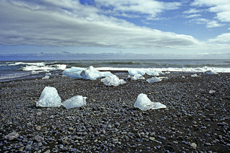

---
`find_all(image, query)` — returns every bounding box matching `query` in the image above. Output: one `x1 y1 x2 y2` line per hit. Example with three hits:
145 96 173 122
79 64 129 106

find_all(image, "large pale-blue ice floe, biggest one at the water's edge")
62 66 113 80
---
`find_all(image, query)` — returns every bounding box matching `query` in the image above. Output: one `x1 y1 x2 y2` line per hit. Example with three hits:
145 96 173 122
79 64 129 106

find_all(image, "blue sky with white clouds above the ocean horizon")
0 0 230 59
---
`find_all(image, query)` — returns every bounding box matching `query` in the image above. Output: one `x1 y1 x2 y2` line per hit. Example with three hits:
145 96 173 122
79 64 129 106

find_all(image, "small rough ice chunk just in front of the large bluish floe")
101 75 126 86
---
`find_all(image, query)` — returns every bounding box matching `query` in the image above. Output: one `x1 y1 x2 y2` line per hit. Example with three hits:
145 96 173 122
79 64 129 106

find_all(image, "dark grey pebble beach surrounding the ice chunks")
0 72 230 153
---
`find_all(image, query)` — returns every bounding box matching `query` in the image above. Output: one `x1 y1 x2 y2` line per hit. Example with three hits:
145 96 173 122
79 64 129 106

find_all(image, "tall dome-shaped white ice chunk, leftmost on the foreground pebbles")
36 87 62 107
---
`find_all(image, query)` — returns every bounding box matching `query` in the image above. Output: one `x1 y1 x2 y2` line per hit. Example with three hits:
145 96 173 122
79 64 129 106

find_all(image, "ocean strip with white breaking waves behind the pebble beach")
0 59 230 82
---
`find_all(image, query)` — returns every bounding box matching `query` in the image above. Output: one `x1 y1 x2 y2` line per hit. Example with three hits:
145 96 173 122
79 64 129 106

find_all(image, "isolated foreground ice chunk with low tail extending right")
134 93 166 111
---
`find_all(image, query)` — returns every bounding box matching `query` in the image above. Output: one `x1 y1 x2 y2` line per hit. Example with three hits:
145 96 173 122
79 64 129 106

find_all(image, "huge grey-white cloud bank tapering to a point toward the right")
0 0 199 48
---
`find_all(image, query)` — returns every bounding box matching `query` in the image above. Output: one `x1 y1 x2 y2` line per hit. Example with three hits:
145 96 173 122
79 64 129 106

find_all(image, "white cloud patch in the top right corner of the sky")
192 0 230 22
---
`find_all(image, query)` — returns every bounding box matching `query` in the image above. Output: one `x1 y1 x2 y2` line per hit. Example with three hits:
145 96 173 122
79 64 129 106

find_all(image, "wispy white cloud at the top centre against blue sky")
95 0 181 18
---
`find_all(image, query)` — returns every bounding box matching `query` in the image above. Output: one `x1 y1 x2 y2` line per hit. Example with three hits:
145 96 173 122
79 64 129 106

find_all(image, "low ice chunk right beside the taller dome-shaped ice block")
62 95 87 109
